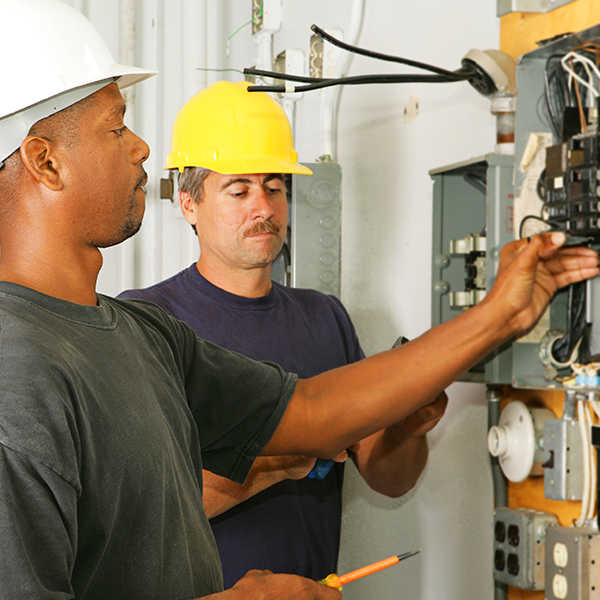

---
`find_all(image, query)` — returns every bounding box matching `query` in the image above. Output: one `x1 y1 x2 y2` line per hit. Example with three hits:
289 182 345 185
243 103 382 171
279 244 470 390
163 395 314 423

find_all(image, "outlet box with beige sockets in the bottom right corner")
545 527 600 600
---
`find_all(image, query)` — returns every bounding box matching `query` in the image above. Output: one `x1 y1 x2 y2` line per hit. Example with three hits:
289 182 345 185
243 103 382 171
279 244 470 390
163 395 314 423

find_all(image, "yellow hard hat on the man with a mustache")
166 81 312 175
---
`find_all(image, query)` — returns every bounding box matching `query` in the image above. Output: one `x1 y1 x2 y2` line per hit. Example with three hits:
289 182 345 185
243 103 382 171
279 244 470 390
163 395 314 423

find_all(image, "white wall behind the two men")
83 0 499 600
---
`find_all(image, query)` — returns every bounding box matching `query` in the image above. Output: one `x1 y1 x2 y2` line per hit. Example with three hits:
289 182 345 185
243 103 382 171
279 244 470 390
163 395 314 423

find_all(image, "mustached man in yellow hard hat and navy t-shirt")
120 81 447 587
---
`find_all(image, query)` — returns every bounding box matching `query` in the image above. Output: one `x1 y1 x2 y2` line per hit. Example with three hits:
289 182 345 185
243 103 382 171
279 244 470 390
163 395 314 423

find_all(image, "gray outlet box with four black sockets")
494 508 558 590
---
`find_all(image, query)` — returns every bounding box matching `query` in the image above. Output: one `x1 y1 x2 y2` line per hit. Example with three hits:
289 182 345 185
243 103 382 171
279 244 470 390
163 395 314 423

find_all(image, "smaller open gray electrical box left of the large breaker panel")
429 154 514 384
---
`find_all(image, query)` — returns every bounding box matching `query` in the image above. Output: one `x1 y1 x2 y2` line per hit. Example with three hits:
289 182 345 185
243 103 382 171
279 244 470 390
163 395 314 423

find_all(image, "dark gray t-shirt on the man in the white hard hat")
0 282 296 600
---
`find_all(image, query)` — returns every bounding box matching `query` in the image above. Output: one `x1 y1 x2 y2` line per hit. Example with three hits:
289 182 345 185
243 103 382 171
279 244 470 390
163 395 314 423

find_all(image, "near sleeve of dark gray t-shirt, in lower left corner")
0 444 77 600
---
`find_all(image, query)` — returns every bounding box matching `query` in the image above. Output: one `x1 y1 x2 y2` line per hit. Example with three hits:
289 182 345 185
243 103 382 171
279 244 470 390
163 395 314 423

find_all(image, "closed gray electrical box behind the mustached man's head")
271 163 342 297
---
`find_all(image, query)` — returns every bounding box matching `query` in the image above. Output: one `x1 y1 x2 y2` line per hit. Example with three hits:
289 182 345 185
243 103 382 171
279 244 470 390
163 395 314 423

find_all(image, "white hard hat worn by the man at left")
0 0 156 167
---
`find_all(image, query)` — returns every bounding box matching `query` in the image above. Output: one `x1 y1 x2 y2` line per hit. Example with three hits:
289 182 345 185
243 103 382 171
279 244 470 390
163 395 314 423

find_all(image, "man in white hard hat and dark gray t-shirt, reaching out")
0 0 599 600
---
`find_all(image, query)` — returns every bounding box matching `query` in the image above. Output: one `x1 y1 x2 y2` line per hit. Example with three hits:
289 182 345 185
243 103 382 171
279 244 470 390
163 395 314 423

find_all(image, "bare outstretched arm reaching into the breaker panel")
263 233 599 457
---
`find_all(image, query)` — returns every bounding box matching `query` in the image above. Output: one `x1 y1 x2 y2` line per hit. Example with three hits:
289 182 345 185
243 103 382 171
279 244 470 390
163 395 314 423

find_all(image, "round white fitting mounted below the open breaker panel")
488 400 554 482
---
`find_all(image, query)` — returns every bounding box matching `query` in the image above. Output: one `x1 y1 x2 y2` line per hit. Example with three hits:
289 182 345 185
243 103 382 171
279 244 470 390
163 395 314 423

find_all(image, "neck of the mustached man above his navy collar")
196 257 272 298
